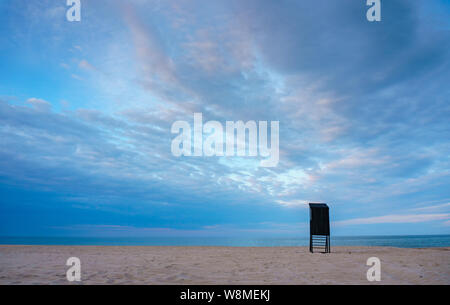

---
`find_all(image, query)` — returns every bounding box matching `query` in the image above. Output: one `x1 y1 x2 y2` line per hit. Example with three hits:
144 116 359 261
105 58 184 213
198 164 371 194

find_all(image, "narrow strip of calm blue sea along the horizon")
0 235 450 248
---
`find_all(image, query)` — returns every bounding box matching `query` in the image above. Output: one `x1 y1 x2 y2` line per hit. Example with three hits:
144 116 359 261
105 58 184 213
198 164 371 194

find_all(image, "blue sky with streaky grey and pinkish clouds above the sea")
0 0 450 237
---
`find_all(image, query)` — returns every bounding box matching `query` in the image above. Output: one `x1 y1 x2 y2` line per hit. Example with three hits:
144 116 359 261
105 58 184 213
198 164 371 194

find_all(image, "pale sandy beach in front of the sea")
0 246 450 285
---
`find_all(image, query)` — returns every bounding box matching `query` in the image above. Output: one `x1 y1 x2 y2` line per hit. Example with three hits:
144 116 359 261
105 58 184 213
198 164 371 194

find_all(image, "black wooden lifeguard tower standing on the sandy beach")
309 203 330 253
